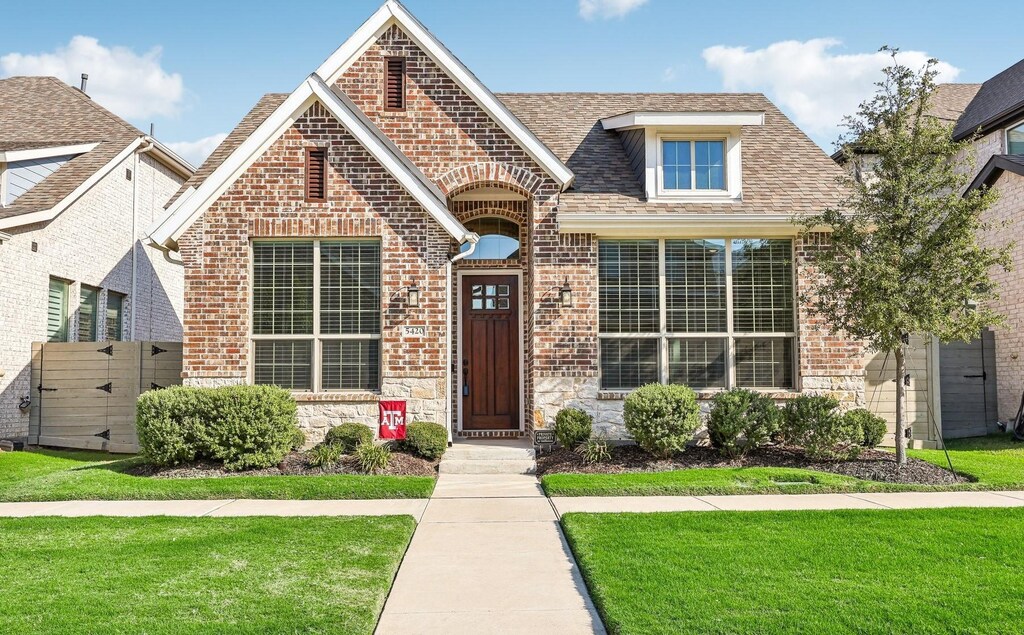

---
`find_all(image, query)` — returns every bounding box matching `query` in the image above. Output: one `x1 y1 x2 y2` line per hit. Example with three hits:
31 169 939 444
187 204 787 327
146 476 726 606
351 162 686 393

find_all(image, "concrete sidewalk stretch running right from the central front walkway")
551 492 1024 518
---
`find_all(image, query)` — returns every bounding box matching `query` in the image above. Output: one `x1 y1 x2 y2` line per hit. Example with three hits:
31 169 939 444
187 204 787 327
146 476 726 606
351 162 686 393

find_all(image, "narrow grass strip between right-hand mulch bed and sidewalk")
541 435 1024 496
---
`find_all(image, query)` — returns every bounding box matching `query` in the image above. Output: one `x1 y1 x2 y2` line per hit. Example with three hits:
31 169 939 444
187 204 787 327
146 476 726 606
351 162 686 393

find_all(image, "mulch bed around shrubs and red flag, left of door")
125 452 438 478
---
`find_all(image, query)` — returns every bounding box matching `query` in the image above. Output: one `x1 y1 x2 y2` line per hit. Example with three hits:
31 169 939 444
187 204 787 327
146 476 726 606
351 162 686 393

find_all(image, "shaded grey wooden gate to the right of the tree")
939 329 996 438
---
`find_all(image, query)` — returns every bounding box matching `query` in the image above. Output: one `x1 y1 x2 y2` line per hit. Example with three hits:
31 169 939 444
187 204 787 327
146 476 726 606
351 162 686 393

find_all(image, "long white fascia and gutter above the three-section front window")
558 213 819 238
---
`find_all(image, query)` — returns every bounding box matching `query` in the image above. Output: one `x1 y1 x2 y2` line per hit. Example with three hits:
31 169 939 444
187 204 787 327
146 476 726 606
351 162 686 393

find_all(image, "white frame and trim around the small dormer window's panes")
644 130 742 203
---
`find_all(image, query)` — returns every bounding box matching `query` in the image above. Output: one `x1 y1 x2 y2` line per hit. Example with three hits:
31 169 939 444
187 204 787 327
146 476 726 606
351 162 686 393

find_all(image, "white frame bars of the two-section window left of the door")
248 237 384 394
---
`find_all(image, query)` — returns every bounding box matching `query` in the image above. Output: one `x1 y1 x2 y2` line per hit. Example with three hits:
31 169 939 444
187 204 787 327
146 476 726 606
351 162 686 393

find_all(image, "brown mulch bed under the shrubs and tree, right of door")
537 446 970 485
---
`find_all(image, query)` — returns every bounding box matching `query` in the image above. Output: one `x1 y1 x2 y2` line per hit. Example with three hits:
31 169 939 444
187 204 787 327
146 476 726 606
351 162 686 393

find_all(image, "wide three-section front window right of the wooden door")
598 239 796 390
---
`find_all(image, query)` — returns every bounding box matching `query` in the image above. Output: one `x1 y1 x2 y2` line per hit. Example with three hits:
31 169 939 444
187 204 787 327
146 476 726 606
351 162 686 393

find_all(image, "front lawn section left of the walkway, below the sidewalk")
0 516 416 635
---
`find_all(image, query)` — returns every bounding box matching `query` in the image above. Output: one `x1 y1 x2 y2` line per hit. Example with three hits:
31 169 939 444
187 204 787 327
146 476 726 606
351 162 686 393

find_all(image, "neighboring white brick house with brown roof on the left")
0 77 194 437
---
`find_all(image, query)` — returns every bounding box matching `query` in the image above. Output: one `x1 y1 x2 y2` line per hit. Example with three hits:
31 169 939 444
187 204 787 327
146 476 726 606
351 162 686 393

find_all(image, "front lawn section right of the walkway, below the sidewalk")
562 509 1024 634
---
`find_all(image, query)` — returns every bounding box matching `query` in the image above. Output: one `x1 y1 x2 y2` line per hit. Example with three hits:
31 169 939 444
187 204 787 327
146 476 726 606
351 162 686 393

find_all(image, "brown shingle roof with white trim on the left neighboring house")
0 77 193 228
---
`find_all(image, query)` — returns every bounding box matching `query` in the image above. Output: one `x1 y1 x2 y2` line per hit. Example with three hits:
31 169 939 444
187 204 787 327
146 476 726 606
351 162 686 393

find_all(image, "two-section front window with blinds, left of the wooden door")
253 241 381 390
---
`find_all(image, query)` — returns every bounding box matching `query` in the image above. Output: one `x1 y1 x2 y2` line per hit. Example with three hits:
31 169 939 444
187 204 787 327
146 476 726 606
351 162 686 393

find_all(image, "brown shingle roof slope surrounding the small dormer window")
499 92 843 217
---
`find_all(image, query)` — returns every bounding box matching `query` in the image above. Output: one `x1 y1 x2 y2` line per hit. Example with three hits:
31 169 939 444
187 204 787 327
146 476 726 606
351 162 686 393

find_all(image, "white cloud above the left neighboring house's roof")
0 35 184 119
